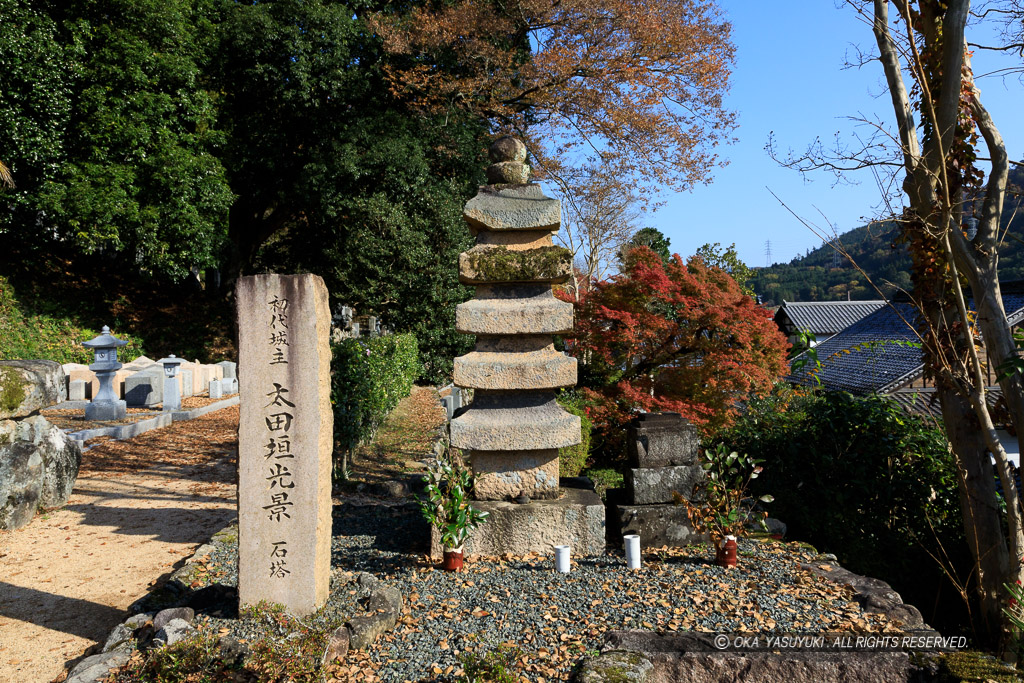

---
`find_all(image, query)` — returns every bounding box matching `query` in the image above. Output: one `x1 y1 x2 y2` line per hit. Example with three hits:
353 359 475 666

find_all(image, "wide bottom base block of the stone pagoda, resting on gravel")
430 479 605 559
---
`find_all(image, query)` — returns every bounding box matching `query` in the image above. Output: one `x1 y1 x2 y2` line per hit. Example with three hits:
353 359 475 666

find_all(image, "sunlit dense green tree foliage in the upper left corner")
4 0 231 280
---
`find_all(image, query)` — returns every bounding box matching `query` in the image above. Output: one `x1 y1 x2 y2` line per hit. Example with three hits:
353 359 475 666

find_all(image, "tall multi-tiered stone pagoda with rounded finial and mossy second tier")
451 137 604 554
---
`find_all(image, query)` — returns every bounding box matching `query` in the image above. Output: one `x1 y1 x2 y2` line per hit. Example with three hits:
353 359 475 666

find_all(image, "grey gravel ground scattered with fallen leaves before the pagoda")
186 503 889 682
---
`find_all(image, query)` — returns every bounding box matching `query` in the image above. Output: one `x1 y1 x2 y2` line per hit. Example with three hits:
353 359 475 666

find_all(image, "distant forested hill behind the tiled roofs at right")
749 168 1024 305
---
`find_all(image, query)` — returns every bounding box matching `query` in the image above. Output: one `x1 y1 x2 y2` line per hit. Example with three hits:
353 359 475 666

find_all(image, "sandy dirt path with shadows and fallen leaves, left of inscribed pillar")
0 407 239 683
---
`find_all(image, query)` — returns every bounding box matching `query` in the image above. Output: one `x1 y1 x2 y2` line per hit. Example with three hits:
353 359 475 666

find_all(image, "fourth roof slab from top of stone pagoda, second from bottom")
453 349 577 389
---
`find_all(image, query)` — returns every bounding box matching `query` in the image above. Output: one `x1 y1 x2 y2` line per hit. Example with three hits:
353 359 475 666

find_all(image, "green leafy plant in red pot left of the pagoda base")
419 452 489 551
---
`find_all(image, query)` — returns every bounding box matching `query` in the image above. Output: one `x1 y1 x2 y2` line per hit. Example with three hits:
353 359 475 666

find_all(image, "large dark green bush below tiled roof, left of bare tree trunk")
715 388 972 633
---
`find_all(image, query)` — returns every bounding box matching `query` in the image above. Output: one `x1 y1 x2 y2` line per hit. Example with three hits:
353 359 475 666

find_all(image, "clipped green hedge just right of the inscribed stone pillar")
331 334 422 456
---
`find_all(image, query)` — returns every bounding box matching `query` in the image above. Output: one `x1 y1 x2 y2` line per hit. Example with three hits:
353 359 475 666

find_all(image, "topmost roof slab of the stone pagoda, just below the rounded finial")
462 185 562 234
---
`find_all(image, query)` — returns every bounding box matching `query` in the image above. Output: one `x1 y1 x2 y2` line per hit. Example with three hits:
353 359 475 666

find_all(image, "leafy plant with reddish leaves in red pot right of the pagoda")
674 444 775 546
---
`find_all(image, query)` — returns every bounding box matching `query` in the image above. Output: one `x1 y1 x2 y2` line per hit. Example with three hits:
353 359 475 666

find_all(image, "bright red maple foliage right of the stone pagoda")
563 247 788 438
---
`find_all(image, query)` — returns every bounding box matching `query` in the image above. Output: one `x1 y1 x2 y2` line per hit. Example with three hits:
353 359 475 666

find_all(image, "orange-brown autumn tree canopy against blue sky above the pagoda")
370 0 734 200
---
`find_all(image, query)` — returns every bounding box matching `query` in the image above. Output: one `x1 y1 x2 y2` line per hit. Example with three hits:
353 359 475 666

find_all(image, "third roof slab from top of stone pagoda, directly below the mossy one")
455 296 572 335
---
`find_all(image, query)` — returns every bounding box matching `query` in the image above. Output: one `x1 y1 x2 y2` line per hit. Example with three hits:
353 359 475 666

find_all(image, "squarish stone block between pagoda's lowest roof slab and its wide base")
469 449 558 501
